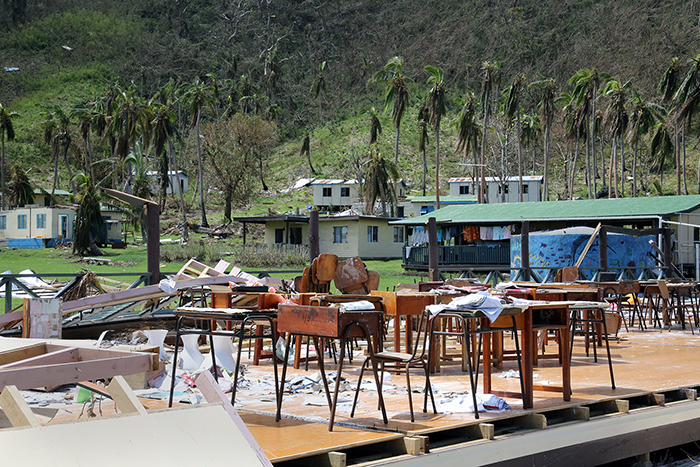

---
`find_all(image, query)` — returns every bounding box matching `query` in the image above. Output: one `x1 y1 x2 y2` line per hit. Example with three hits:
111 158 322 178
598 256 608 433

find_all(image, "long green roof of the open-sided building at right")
392 195 700 225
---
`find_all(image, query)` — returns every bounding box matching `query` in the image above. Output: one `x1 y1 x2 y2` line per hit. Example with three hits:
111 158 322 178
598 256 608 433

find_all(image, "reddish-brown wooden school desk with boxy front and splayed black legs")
277 304 388 431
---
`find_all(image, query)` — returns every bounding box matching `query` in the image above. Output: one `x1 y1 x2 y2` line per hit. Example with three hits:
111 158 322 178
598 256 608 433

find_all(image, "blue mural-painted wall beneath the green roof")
510 234 657 278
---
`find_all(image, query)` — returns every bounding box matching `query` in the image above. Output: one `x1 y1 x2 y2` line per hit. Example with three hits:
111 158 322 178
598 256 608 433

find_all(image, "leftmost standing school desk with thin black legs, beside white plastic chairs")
168 306 281 407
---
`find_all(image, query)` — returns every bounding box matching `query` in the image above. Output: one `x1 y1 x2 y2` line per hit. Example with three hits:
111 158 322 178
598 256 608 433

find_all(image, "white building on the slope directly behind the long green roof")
447 175 544 203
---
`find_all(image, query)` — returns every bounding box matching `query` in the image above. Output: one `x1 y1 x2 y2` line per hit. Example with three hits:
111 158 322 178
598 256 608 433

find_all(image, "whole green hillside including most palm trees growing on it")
0 0 700 227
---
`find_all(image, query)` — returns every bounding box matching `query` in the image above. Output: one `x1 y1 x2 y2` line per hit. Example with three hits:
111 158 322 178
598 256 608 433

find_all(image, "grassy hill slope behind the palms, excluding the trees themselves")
0 0 700 225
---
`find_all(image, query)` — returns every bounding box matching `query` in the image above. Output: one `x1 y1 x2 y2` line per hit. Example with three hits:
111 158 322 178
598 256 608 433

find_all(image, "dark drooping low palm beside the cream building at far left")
73 172 104 256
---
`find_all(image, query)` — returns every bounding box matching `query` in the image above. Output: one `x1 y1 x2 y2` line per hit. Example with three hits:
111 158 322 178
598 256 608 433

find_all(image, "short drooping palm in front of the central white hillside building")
363 144 400 216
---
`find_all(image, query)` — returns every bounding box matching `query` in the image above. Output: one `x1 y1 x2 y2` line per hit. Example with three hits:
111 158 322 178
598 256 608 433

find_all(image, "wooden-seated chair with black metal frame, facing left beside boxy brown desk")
350 310 437 422
